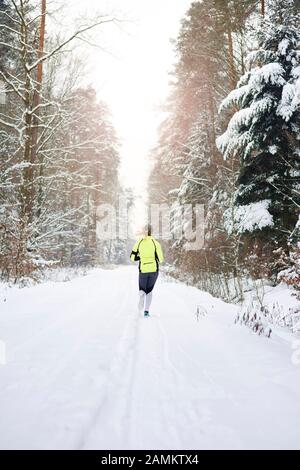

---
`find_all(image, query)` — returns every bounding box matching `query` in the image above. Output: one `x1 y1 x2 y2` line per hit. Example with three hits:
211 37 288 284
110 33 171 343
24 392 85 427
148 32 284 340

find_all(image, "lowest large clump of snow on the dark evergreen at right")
224 199 274 234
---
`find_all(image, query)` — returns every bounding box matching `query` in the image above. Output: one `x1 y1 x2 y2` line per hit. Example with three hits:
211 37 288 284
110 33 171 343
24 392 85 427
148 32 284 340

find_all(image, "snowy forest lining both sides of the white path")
0 0 300 301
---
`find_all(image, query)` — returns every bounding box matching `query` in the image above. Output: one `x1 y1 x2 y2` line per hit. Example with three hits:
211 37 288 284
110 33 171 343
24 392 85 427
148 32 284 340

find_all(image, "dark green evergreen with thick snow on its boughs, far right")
217 0 300 274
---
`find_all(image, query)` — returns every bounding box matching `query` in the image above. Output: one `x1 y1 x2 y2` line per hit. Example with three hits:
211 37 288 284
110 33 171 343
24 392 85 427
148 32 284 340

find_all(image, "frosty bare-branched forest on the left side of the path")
0 0 122 282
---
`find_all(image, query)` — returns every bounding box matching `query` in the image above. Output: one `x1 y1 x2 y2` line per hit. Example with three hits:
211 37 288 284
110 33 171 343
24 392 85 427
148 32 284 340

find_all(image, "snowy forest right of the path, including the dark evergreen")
149 0 300 300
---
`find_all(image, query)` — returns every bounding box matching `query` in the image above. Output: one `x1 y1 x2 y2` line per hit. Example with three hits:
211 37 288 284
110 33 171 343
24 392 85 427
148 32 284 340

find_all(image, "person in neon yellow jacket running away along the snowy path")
130 225 164 317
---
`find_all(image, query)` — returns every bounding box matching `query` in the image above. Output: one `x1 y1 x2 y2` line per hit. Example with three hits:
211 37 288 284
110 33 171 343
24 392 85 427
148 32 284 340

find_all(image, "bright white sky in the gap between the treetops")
51 0 191 227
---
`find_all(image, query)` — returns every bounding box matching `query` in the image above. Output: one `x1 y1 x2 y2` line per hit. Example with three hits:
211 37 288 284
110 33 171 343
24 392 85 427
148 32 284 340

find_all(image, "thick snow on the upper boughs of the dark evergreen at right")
216 48 300 156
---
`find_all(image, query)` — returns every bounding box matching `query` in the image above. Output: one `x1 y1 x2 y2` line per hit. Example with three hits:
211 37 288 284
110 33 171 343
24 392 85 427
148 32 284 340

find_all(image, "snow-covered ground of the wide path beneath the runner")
0 267 300 449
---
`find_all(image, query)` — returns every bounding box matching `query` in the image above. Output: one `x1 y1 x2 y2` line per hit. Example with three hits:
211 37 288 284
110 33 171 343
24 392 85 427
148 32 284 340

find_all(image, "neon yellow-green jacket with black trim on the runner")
130 237 164 273
